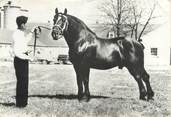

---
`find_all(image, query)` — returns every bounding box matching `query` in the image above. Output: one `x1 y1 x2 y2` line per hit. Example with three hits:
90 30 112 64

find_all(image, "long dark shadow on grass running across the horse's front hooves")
29 94 109 100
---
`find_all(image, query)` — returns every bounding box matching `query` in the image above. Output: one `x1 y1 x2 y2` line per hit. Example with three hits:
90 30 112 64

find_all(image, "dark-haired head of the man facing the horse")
16 16 28 30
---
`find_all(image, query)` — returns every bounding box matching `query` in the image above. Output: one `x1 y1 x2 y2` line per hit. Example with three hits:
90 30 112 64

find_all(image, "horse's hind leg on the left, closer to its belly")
128 67 147 100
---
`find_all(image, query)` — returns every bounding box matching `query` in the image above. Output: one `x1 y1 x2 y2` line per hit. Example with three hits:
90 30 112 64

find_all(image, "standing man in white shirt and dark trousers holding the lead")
13 16 39 107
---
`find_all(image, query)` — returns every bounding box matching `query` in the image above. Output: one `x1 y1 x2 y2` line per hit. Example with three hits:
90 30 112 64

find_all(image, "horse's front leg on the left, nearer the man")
73 65 84 100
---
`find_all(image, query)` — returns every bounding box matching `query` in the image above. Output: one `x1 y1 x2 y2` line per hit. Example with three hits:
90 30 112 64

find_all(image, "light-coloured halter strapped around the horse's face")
52 13 68 38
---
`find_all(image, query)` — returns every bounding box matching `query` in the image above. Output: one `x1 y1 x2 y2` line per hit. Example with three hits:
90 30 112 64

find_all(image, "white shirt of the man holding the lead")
12 29 32 59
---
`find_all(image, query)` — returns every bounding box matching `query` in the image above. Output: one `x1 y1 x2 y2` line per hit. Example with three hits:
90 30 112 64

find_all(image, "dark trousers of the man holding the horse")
14 57 29 107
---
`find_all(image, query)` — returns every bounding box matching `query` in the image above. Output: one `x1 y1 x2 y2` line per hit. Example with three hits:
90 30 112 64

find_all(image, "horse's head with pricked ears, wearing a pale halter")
51 8 68 40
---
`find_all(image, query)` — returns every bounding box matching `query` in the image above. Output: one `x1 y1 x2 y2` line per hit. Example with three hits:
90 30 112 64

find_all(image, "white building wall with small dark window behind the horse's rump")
143 23 171 65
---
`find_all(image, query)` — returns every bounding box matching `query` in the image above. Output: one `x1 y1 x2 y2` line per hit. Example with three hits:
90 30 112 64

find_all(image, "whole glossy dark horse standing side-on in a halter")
51 8 154 101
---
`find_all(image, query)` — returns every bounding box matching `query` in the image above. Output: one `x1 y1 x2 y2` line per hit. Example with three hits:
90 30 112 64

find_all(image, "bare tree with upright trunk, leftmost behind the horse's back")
100 0 131 37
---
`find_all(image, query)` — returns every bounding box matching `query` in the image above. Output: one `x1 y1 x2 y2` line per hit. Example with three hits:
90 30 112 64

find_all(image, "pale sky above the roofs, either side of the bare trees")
0 0 171 24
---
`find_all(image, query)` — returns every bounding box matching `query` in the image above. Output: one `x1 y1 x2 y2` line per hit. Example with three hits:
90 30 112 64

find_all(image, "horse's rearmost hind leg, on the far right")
142 69 154 100
